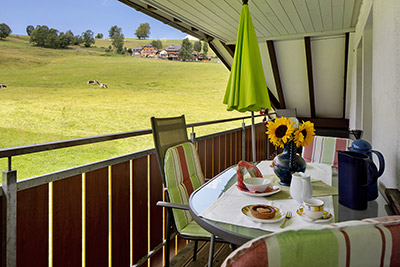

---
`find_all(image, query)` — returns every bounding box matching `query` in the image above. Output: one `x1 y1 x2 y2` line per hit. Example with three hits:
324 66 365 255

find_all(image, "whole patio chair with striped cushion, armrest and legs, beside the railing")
151 115 230 266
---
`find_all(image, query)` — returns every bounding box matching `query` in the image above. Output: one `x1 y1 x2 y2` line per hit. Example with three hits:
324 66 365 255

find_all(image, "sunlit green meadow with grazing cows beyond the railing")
0 36 248 179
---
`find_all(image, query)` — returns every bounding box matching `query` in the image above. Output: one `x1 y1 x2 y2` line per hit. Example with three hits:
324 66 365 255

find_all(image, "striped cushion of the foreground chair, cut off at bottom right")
222 216 400 267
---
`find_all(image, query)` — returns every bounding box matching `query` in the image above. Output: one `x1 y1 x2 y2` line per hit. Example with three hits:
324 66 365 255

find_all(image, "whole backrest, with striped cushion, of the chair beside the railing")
151 115 204 232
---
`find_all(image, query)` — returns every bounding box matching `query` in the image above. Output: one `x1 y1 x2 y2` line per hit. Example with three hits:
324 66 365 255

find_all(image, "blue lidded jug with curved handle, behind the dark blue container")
348 139 385 201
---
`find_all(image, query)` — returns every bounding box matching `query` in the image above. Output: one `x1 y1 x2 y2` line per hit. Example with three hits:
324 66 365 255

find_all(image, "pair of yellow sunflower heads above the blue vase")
266 117 315 148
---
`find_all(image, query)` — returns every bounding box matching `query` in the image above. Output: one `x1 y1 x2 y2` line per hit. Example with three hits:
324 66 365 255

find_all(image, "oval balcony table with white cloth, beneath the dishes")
189 161 393 245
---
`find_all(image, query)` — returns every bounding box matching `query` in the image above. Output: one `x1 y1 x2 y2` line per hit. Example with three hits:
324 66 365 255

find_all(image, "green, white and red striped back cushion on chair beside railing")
164 142 204 232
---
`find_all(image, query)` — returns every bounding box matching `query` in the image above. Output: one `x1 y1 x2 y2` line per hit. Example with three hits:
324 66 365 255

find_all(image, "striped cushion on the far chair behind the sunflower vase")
302 136 353 167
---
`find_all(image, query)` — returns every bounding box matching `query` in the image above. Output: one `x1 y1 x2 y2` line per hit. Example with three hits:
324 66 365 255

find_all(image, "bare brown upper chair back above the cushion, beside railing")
151 115 189 185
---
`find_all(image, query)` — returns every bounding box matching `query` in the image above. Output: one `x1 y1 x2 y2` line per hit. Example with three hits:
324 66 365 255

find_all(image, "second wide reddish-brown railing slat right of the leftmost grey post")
53 175 82 266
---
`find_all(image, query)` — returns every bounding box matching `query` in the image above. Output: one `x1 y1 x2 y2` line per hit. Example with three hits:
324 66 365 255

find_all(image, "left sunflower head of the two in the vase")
266 117 295 148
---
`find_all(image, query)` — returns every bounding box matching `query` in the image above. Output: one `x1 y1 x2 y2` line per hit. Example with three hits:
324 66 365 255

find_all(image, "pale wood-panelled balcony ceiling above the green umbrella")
120 0 362 44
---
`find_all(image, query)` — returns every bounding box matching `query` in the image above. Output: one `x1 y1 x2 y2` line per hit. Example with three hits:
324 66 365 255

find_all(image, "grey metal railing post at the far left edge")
1 170 17 267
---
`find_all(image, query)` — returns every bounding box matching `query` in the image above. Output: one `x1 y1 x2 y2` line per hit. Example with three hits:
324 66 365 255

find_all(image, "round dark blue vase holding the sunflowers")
272 141 306 186
